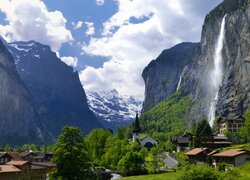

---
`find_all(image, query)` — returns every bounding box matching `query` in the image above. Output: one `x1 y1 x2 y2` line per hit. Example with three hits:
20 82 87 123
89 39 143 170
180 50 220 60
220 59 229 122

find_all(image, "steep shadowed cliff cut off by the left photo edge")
0 38 46 145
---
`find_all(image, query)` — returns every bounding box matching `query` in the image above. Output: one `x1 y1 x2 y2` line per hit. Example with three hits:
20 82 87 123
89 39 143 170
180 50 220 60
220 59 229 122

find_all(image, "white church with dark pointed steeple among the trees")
133 114 157 150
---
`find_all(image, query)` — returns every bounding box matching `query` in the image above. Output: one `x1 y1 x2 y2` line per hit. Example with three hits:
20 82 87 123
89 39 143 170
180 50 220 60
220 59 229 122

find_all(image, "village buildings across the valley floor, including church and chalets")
0 115 250 180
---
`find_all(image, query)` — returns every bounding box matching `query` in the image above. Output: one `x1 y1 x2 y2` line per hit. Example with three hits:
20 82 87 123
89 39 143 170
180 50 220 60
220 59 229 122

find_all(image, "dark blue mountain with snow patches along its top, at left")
8 41 102 138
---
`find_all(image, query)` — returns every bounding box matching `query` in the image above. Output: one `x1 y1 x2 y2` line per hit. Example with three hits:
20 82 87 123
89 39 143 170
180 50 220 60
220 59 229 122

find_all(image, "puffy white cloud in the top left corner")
0 0 73 51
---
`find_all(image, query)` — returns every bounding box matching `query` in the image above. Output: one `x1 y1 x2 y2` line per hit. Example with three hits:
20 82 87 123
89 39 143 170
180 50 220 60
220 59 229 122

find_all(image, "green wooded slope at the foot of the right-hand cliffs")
140 89 190 138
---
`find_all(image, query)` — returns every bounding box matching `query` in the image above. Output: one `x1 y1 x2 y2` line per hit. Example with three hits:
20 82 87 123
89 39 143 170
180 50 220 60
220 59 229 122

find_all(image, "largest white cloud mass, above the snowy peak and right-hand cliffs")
80 0 222 96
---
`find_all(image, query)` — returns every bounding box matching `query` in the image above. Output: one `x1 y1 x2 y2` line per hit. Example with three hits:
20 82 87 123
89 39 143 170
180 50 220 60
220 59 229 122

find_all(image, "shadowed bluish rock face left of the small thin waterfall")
142 43 198 112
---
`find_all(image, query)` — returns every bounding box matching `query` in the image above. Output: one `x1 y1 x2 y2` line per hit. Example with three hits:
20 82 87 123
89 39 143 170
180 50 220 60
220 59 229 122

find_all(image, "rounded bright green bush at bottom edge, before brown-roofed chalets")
179 164 219 180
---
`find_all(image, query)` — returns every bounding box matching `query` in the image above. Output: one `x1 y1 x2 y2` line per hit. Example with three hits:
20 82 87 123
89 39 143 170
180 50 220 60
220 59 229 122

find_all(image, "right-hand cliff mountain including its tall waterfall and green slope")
141 0 250 131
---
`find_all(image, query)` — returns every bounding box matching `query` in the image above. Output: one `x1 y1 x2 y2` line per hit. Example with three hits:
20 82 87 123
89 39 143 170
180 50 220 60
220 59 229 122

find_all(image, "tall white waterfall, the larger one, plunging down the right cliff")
208 15 226 126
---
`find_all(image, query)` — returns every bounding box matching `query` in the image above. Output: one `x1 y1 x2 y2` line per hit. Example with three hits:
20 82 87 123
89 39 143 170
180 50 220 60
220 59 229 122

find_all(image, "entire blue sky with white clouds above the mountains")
0 0 222 97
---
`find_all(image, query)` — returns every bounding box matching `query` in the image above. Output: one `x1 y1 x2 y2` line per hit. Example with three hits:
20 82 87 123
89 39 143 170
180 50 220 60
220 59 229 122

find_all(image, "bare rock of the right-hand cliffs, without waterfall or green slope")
143 0 250 122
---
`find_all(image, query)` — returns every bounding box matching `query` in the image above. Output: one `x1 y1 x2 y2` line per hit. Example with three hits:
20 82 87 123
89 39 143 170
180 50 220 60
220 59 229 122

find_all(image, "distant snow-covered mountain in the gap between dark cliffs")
86 89 142 131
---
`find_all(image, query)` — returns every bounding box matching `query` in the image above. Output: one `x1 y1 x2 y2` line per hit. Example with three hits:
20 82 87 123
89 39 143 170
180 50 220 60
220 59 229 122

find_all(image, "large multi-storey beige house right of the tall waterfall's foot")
217 116 246 135
